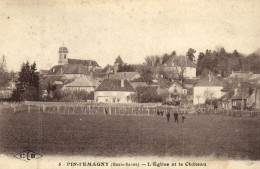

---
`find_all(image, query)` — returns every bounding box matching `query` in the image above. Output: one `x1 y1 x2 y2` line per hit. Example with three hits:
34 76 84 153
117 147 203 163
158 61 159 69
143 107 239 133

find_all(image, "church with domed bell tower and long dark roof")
44 46 100 79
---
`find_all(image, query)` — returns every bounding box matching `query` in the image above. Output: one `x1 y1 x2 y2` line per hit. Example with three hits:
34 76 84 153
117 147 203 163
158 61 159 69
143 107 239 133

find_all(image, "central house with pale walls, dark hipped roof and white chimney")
94 79 136 103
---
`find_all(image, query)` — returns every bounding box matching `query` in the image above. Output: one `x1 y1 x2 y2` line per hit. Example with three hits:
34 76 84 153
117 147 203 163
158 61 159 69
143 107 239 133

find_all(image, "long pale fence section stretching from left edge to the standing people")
0 102 184 116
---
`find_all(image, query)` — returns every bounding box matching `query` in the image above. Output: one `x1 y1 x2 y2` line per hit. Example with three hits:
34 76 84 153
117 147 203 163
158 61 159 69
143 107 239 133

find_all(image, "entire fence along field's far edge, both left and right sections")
0 102 260 117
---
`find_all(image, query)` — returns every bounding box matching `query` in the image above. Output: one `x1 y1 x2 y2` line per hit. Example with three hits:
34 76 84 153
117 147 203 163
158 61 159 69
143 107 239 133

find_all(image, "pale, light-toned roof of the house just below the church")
65 76 97 87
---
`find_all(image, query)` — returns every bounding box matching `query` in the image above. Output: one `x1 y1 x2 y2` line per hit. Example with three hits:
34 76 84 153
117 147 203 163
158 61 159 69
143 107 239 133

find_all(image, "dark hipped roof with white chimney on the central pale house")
95 79 136 92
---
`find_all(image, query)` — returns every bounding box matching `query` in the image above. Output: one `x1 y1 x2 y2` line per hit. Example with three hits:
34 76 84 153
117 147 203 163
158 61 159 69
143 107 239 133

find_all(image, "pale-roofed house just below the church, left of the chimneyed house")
61 76 97 92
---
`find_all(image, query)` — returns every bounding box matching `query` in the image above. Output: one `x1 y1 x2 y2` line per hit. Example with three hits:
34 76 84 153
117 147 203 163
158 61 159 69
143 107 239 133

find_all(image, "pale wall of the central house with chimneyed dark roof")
94 91 135 103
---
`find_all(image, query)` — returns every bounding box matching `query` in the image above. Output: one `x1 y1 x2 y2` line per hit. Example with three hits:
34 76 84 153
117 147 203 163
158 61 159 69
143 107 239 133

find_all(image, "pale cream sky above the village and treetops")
0 0 260 71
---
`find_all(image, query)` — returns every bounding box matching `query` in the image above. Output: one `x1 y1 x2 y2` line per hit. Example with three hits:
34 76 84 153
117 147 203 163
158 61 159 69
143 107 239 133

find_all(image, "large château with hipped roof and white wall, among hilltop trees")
163 56 197 79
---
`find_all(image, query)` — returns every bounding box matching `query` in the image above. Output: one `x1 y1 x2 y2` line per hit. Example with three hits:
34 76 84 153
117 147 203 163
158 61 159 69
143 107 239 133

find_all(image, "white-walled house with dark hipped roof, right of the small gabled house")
193 74 223 105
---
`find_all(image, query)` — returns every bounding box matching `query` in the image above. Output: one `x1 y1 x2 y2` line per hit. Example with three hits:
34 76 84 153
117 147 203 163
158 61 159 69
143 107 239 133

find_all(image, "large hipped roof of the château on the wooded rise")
163 56 197 68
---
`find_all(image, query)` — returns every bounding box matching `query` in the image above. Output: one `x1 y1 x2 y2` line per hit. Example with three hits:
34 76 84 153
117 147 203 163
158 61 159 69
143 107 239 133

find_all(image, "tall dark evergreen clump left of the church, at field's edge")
12 61 39 101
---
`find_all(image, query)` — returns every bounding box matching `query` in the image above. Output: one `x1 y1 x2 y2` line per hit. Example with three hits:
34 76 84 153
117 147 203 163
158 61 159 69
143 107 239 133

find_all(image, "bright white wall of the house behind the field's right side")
193 86 223 105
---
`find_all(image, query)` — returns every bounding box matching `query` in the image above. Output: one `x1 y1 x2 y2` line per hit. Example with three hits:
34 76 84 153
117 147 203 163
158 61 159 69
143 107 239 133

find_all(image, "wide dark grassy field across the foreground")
0 113 260 160
